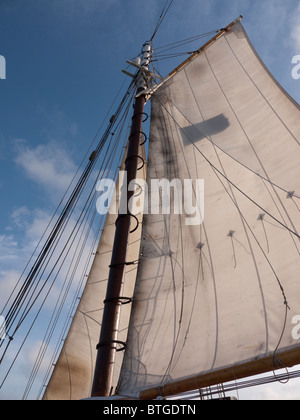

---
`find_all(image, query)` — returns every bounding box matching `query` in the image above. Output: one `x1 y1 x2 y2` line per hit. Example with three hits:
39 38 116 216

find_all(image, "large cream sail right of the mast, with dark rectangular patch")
118 23 300 397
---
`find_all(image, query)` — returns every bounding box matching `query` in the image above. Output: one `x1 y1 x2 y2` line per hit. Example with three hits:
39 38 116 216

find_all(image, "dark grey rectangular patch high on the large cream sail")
181 114 230 146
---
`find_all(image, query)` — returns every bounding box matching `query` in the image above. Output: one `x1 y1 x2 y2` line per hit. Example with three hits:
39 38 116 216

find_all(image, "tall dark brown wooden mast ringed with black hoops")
92 42 152 397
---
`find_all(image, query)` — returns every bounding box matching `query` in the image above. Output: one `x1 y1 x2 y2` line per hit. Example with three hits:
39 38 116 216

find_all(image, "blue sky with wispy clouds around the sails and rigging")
0 0 300 398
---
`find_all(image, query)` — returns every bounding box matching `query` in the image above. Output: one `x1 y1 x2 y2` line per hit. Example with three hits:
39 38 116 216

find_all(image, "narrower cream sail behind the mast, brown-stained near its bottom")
43 147 146 400
